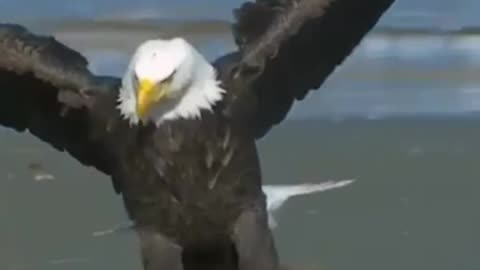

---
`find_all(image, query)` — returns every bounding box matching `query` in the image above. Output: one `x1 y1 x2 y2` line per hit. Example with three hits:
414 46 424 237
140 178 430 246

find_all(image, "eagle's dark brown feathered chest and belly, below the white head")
118 114 263 246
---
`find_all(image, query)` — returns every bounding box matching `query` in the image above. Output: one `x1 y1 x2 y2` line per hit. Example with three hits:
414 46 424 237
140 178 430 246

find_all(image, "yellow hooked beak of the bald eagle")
137 80 169 120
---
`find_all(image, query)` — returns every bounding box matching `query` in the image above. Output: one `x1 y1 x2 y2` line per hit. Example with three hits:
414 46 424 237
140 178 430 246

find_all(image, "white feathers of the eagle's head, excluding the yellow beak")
119 38 225 125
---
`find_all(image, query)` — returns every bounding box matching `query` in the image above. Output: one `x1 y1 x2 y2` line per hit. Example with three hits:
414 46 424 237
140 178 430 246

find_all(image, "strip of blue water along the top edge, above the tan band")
0 0 480 27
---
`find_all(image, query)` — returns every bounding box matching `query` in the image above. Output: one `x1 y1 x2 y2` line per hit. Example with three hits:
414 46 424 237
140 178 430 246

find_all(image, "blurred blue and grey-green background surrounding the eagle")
0 0 480 270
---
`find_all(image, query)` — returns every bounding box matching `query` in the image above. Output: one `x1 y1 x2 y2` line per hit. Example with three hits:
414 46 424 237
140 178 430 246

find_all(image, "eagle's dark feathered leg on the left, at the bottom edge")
137 229 183 270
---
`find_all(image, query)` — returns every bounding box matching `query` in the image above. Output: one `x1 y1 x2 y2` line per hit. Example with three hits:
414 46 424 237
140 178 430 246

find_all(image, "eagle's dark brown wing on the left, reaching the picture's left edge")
0 24 125 186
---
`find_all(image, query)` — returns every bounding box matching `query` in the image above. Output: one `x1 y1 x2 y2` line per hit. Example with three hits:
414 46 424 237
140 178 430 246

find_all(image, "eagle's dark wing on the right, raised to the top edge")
216 0 394 137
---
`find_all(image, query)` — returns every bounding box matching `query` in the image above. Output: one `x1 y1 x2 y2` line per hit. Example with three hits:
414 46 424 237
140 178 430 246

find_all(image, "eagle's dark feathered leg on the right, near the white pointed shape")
233 207 279 270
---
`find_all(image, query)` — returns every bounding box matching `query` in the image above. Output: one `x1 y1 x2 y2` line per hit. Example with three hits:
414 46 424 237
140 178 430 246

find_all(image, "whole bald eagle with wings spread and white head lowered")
0 0 393 270
